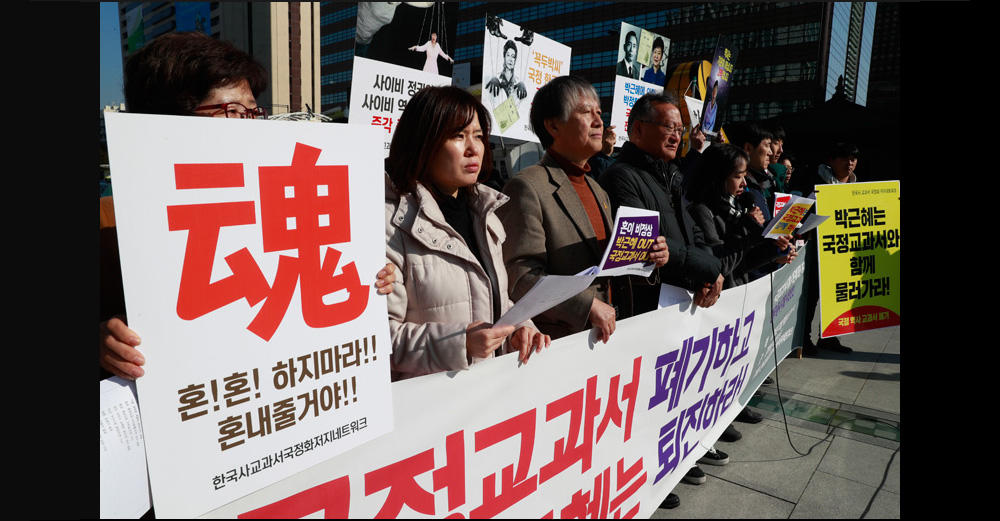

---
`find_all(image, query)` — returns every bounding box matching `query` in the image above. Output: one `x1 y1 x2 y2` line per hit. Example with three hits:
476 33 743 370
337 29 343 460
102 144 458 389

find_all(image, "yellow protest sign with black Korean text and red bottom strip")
816 181 900 338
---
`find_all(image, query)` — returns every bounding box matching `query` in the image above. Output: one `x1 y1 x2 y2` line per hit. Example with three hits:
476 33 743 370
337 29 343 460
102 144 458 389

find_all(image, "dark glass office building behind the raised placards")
320 2 877 120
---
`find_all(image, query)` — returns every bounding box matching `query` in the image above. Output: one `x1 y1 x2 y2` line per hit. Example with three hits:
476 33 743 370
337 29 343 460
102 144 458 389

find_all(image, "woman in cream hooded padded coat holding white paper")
385 87 550 380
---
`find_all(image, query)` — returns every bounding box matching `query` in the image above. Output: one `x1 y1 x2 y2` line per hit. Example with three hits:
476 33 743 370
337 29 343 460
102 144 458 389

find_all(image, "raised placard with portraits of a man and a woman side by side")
611 22 670 147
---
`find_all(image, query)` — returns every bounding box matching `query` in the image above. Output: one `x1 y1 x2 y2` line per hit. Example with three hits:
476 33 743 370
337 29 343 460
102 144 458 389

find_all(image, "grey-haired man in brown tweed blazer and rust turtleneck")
497 76 668 342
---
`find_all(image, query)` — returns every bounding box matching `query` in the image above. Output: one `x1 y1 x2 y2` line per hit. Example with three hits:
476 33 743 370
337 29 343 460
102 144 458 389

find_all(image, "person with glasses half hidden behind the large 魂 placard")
98 32 396 379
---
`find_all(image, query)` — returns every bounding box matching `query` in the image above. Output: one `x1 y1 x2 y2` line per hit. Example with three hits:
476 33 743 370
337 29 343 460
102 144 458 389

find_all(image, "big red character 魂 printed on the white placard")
167 143 369 340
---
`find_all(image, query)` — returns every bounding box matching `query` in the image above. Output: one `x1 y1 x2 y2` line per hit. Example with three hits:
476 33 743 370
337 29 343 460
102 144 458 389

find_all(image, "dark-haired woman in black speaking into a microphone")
688 143 796 289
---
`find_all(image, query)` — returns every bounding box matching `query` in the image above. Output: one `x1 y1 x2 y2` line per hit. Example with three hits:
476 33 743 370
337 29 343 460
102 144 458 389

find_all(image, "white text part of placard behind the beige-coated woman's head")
348 56 451 157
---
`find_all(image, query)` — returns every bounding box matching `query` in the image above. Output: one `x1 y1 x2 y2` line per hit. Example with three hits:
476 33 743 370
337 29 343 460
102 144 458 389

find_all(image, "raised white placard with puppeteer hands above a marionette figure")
482 14 571 143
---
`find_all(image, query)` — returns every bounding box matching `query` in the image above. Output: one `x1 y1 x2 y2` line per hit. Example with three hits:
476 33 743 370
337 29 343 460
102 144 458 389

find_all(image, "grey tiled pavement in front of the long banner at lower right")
653 327 901 519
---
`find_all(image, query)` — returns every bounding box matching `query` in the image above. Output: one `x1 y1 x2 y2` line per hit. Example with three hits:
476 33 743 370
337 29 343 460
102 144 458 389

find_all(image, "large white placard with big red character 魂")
105 113 393 517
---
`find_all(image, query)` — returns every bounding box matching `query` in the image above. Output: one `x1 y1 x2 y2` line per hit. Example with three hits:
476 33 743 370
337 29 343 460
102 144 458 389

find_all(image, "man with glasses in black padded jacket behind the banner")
601 93 729 490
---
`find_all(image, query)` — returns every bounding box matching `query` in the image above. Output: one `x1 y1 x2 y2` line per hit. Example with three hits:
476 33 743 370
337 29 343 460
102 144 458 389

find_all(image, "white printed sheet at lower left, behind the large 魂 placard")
100 376 150 519
